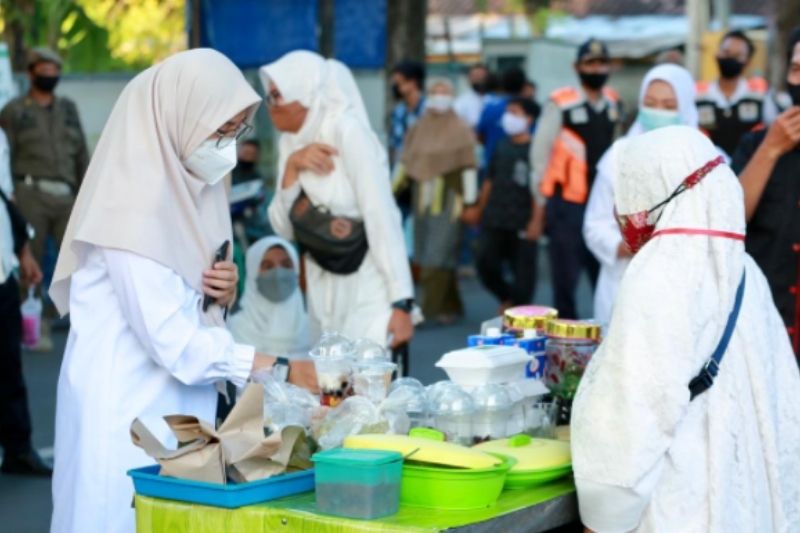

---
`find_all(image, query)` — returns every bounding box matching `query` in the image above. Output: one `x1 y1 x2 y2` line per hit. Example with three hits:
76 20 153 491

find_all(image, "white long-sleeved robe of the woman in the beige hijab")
51 247 254 533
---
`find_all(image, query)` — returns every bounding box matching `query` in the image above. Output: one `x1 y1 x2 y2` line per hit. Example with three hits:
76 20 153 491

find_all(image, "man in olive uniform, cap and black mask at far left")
0 48 89 351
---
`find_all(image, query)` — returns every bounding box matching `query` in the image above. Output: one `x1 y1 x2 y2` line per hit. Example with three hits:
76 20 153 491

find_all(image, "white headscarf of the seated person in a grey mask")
229 237 310 356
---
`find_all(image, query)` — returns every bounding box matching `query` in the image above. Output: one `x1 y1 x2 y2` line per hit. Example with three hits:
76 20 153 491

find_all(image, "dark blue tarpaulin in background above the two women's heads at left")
194 0 386 68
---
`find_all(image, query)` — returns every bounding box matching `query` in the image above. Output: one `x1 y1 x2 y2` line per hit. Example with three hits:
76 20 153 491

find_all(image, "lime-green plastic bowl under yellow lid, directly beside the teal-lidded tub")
398 453 516 511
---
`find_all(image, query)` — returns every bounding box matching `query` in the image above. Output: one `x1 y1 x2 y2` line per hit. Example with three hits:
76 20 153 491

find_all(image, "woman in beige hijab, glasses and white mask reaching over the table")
50 49 313 533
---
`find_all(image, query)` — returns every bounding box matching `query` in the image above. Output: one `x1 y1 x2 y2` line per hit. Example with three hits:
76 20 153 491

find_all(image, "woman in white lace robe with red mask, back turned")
572 126 800 533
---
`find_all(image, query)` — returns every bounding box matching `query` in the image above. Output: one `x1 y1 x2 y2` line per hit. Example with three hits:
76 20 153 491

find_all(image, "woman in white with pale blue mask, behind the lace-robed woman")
583 65 698 324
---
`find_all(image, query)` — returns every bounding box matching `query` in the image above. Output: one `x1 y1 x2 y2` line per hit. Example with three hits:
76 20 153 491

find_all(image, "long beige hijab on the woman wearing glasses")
50 49 261 315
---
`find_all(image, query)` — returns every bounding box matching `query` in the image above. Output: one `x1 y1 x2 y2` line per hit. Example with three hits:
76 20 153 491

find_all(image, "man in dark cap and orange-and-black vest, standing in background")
529 39 619 318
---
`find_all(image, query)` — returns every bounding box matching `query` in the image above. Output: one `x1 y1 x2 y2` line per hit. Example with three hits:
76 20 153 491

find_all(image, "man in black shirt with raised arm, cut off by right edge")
732 28 800 356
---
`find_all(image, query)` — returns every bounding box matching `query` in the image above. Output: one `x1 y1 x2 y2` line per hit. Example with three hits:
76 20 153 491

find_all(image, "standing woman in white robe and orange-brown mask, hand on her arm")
260 52 413 346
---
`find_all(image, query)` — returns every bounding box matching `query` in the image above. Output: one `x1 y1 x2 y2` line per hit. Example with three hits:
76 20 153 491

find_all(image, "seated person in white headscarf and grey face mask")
228 237 310 357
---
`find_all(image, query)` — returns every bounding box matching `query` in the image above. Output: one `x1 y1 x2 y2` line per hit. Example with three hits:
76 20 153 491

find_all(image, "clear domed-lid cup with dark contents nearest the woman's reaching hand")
309 333 355 407
